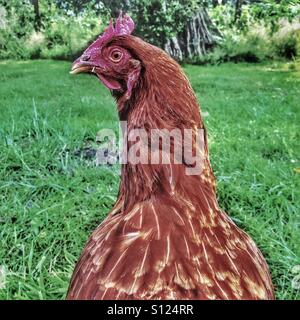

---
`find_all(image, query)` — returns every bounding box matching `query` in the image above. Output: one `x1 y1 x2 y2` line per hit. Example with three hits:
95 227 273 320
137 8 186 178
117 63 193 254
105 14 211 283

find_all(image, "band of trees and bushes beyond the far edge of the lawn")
0 0 300 64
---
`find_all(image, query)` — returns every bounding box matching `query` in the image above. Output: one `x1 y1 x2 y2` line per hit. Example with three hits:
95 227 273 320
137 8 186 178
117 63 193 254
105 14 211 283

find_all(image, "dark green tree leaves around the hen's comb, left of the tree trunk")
56 0 207 46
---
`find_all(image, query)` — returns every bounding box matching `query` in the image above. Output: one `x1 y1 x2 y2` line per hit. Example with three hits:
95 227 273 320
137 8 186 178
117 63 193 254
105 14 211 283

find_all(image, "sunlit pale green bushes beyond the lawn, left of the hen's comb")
0 0 108 59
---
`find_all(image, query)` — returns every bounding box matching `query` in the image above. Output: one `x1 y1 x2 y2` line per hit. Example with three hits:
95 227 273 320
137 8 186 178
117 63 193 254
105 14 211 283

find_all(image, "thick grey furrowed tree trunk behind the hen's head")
164 8 221 61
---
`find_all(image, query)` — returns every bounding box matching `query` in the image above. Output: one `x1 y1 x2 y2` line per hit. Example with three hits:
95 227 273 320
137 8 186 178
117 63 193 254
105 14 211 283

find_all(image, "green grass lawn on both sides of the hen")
0 61 300 299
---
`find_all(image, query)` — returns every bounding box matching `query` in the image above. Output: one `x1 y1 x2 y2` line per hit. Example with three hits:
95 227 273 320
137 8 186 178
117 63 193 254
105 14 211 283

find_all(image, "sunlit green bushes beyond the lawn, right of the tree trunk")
205 1 300 63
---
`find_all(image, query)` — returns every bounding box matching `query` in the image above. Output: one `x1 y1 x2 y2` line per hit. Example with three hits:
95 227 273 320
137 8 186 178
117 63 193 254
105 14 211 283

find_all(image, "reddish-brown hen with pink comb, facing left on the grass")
67 14 274 299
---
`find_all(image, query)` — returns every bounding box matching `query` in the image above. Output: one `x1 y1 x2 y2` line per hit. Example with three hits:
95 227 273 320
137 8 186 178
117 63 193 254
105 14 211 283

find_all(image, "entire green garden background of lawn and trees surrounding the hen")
0 0 300 300
